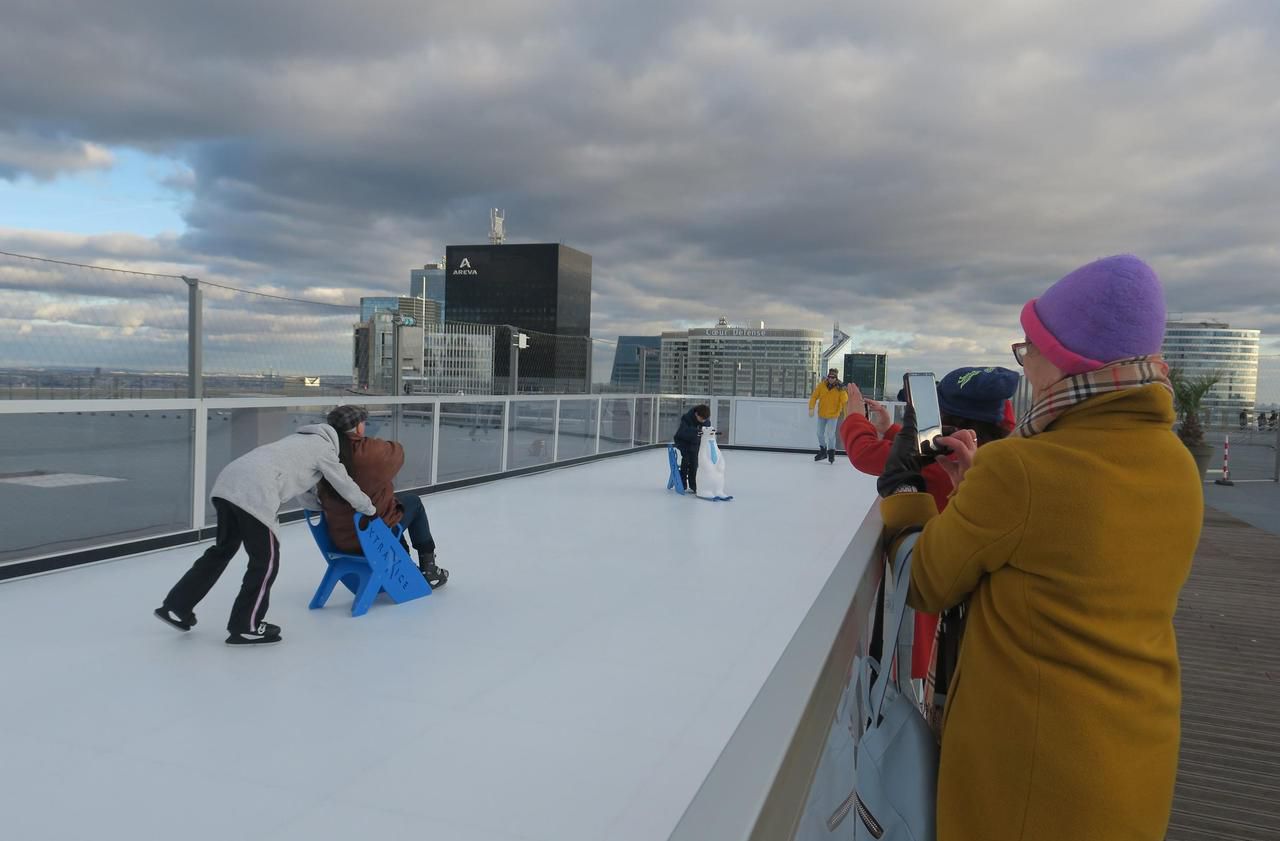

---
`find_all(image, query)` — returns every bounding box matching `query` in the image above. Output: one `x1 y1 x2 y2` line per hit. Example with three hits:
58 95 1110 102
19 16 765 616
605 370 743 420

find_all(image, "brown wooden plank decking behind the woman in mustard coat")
1166 508 1280 841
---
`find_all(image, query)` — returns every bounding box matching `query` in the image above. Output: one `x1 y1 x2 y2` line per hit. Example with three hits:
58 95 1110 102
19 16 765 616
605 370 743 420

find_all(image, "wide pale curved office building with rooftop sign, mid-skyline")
662 319 824 397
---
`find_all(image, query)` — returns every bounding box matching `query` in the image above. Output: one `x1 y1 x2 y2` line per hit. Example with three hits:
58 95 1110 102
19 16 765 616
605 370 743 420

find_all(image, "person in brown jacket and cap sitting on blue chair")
317 406 449 590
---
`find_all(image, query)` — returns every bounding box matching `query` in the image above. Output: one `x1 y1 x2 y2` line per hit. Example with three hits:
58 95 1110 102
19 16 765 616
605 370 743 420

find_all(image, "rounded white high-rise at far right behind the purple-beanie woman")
1162 321 1262 415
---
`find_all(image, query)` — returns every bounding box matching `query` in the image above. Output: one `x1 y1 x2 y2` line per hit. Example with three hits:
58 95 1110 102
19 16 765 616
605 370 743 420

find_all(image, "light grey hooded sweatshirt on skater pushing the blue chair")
210 424 378 533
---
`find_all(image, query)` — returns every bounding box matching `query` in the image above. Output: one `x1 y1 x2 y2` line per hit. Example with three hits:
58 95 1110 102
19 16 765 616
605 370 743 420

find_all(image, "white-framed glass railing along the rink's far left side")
0 394 890 568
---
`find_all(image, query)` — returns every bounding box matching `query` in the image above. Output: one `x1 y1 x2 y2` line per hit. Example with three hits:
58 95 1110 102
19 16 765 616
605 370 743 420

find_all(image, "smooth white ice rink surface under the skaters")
0 451 874 841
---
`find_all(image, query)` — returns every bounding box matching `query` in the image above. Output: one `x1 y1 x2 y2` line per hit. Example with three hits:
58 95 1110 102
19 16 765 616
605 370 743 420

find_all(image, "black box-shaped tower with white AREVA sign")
444 243 591 392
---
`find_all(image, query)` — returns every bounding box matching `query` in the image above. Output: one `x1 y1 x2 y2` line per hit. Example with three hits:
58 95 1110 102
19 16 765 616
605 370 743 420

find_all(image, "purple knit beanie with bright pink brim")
1021 253 1165 375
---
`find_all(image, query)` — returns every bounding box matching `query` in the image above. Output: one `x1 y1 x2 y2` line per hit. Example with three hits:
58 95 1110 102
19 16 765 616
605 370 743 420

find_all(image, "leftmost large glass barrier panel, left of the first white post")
0 410 193 562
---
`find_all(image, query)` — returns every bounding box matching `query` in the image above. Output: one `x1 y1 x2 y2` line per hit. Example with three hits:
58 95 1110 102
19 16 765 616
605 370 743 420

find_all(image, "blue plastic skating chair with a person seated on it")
306 511 431 616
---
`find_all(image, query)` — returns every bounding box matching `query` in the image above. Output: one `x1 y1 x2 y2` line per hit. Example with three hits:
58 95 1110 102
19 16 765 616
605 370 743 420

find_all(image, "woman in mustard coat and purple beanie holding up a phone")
878 255 1203 841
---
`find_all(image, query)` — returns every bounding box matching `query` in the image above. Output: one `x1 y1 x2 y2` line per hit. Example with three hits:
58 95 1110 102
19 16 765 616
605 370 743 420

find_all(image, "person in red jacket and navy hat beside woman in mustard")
840 367 1019 680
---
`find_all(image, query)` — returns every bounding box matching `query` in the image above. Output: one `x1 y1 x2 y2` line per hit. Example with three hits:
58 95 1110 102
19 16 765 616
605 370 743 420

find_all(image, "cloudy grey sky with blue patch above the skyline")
0 0 1280 402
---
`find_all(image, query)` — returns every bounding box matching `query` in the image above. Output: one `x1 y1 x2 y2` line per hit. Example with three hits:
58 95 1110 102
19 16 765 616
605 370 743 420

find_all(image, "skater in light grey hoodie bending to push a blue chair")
155 424 376 645
